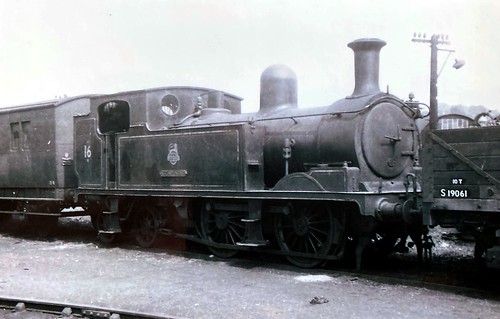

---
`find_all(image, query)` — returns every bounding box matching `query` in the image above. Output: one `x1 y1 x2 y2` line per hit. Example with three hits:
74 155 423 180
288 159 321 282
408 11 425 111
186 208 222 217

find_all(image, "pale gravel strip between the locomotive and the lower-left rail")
0 218 500 319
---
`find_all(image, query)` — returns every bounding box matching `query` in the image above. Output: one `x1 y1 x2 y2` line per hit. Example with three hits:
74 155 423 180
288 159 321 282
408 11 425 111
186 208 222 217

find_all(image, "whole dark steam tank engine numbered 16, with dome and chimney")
76 39 426 267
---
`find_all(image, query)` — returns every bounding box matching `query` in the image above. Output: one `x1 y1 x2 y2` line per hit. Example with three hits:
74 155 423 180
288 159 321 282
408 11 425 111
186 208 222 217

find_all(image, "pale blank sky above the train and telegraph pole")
0 0 500 112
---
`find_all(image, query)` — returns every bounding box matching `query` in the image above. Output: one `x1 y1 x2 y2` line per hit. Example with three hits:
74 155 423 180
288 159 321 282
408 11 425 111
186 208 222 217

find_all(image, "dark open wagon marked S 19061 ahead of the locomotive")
422 121 500 267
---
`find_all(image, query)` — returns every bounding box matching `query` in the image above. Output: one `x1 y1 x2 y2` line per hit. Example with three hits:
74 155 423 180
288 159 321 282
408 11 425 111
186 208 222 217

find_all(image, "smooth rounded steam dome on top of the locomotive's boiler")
259 64 297 113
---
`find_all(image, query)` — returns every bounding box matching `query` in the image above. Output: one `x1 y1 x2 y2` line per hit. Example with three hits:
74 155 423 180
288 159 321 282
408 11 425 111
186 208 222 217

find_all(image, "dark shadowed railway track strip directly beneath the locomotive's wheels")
0 218 500 299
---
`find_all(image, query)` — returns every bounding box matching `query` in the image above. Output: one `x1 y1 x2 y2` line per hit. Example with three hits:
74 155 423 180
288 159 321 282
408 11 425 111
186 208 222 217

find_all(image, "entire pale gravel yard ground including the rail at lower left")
0 221 500 319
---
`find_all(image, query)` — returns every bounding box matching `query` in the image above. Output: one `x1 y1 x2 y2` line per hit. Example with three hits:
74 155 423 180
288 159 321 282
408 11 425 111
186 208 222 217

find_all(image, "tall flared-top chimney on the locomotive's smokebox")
347 39 386 98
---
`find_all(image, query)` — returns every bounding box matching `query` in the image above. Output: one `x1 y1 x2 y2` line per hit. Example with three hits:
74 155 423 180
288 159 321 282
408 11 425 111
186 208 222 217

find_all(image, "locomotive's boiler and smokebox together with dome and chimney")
261 39 420 205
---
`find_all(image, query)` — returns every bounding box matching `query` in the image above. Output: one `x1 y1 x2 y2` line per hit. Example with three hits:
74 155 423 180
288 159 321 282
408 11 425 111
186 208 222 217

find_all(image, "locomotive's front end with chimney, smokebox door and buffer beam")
334 39 421 228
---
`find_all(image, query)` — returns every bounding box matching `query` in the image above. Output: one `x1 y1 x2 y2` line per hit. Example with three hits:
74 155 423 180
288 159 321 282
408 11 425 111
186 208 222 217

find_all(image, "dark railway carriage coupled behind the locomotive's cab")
0 96 89 222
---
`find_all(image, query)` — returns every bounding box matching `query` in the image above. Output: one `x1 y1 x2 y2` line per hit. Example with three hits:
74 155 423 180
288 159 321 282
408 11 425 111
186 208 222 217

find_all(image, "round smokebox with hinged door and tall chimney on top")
319 39 418 185
